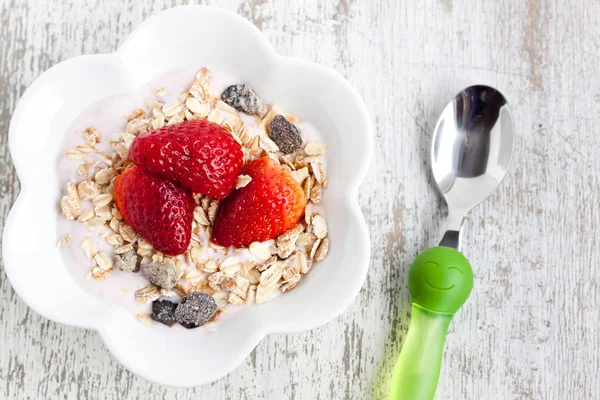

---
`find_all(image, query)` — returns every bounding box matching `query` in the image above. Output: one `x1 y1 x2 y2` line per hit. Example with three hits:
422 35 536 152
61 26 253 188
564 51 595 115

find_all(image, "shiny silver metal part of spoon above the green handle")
431 85 514 250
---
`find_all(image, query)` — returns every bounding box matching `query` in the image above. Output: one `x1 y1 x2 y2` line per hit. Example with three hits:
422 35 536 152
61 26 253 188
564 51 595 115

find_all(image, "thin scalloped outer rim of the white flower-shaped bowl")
2 5 374 387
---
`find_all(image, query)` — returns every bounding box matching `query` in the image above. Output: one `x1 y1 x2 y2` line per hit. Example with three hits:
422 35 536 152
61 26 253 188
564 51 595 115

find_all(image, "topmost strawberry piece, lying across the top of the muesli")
129 120 243 199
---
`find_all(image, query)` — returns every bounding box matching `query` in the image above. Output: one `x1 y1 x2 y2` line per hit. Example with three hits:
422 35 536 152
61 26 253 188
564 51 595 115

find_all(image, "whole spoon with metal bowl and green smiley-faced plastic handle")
390 85 514 400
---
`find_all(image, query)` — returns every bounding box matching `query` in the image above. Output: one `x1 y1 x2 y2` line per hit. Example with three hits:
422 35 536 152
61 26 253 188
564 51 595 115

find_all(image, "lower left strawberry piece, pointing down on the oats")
114 167 195 255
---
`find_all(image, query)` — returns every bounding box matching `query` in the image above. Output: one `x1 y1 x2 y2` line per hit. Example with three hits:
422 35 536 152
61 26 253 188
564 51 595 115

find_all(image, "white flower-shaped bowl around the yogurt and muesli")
3 6 373 387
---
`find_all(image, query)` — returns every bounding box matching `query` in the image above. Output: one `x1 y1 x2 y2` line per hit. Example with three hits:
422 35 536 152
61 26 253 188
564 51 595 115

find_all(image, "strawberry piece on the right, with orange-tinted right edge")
212 157 306 247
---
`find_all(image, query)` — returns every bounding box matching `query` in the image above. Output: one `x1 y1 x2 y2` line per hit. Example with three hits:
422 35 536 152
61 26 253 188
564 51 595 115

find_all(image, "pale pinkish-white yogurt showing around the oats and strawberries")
57 66 326 318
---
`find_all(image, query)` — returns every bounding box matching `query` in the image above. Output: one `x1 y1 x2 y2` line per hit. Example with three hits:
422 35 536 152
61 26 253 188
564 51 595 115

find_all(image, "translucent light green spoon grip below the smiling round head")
390 304 452 400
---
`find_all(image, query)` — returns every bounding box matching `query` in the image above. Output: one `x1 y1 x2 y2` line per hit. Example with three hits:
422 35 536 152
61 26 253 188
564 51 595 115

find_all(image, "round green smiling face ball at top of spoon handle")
408 246 473 314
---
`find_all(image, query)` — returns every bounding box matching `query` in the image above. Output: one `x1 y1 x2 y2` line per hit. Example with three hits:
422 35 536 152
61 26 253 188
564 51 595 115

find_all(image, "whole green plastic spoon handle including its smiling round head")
389 247 473 400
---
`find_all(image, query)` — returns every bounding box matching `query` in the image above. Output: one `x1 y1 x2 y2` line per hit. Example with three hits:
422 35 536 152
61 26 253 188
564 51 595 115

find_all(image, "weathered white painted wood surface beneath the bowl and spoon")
0 0 600 400
